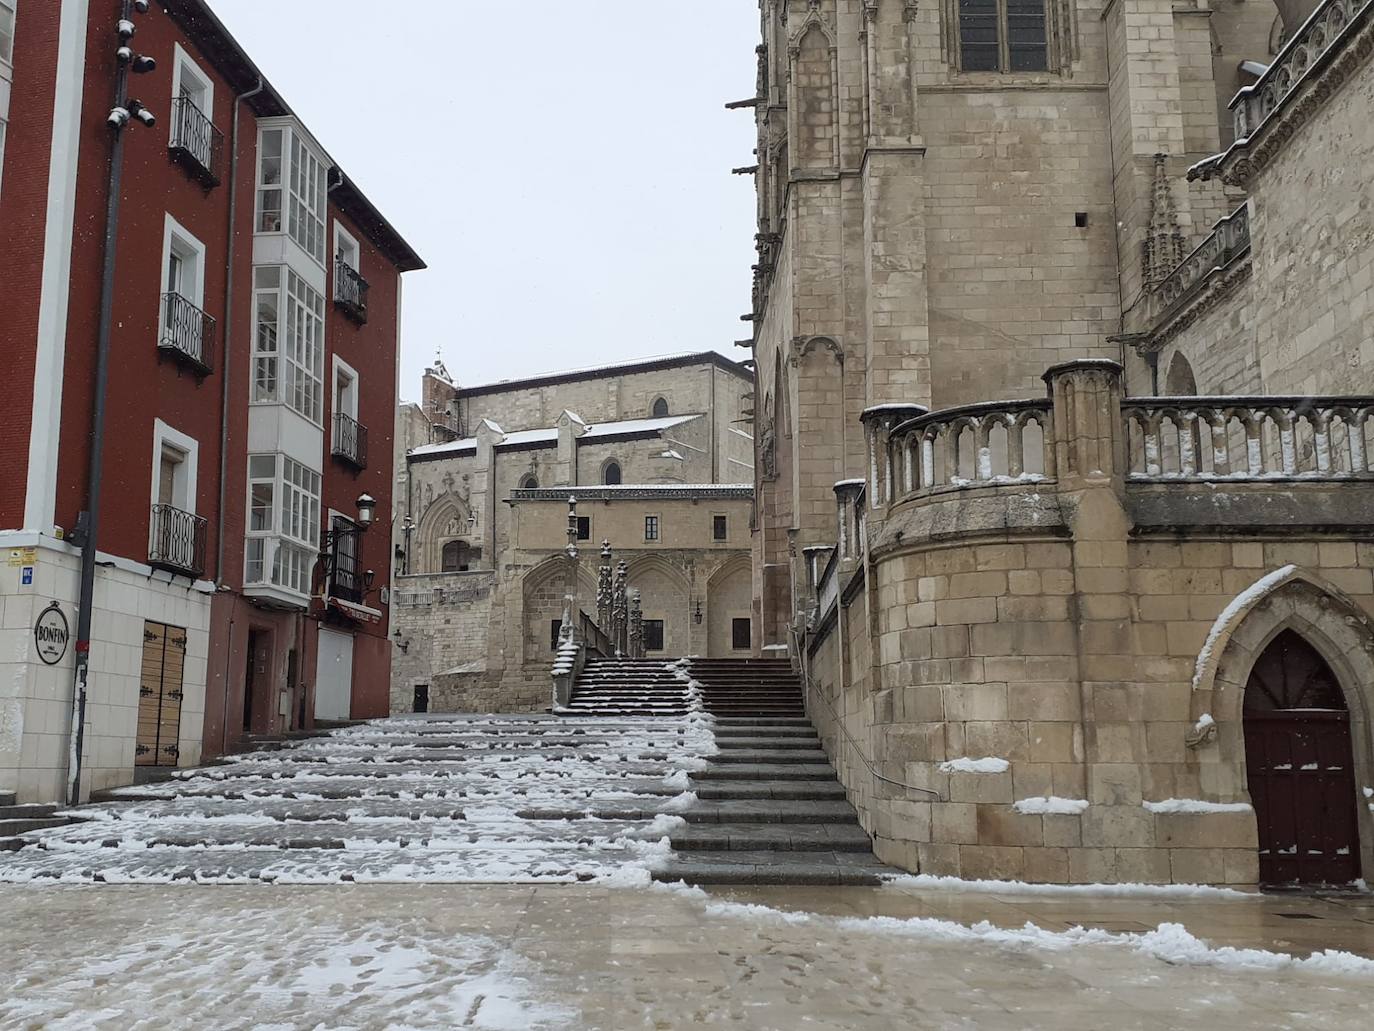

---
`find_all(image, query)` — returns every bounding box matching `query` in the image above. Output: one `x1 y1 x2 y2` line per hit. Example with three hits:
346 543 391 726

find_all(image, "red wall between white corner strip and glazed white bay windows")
56 3 256 566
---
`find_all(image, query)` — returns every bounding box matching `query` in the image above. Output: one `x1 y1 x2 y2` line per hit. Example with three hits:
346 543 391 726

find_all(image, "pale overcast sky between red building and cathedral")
212 0 758 399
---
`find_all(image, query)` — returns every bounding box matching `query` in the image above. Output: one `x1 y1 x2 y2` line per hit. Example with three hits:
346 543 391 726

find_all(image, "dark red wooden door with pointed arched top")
1245 630 1360 884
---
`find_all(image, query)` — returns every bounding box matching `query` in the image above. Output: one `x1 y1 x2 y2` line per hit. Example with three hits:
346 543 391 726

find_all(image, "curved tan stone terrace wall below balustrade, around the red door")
807 364 1374 885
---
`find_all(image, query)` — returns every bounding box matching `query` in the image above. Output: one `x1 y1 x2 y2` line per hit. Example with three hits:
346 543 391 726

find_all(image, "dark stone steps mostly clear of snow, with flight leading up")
570 658 888 884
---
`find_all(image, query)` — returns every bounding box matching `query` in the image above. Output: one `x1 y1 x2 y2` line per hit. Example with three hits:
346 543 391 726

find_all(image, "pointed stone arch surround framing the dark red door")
1190 566 1374 880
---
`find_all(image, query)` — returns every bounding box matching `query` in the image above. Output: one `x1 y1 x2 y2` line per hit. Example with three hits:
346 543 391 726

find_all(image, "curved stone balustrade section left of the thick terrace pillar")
888 399 1054 498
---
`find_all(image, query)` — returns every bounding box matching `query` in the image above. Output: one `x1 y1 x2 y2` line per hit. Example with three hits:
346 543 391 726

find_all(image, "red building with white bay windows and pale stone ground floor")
0 0 423 801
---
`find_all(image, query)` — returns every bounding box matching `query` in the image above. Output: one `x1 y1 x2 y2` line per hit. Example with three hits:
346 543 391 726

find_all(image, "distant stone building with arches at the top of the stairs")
392 352 756 712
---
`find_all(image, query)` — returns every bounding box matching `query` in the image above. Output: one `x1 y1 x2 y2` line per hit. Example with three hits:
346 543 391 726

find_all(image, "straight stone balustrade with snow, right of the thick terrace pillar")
1121 397 1374 480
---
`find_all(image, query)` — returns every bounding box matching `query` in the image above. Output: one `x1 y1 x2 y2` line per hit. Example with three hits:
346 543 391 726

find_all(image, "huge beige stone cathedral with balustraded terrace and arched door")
747 0 1374 885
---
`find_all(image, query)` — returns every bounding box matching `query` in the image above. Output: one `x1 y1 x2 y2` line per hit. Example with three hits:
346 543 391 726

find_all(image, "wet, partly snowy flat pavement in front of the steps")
0 884 1374 1031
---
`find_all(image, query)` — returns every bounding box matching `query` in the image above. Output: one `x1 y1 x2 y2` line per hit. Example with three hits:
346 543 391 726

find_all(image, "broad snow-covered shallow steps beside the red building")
0 716 714 884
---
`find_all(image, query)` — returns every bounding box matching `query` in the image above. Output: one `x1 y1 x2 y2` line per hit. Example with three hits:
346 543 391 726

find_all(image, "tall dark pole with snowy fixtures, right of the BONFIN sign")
67 0 133 806
